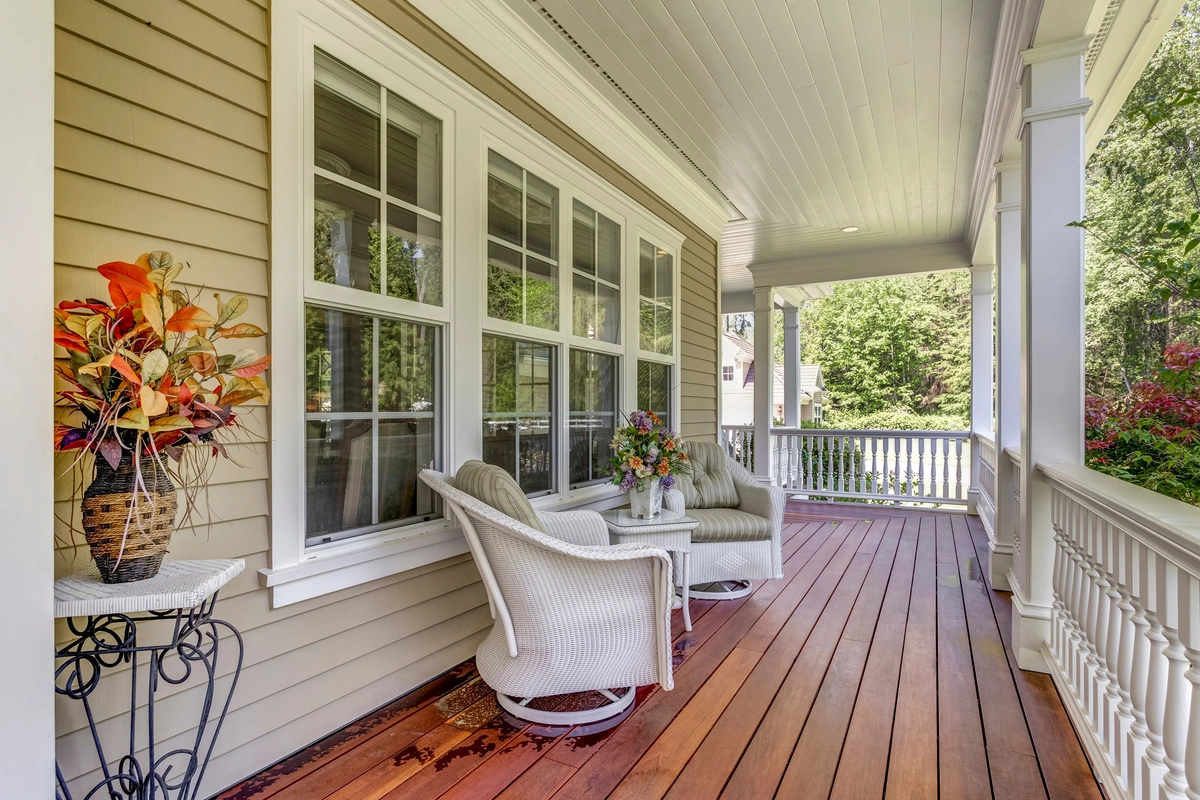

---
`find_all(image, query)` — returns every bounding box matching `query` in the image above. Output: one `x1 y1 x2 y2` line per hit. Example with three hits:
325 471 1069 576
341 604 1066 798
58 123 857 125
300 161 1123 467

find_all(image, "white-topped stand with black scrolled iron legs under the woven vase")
54 559 246 800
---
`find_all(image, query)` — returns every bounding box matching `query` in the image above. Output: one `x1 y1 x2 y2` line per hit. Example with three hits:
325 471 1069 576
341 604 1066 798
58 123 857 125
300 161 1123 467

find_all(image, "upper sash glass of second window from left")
487 151 558 330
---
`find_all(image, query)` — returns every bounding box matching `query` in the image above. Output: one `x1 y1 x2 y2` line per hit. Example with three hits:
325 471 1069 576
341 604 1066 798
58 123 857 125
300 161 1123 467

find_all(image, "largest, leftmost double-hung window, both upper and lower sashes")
304 49 444 546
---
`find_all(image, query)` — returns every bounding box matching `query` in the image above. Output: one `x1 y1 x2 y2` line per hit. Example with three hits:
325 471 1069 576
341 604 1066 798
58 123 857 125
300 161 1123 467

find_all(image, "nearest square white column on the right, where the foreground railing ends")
1013 36 1091 672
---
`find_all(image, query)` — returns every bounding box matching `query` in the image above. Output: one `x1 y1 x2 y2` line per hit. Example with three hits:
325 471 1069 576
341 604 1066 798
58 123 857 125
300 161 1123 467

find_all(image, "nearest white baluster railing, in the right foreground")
1039 464 1200 800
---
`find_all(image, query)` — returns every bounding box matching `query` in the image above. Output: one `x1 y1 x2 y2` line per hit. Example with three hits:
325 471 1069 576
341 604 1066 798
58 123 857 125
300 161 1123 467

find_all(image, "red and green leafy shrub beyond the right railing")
1084 342 1200 506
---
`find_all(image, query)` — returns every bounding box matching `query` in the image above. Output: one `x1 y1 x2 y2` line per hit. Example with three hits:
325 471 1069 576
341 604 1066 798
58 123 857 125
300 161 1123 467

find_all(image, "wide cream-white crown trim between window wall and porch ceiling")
412 0 730 240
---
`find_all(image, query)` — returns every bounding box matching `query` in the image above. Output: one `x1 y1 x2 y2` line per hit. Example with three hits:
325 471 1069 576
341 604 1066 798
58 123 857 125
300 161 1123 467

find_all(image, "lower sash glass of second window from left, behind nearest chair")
482 336 556 495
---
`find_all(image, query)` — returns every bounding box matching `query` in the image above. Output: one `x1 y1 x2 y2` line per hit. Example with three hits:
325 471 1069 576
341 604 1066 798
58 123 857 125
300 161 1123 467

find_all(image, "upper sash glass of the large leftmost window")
313 50 443 306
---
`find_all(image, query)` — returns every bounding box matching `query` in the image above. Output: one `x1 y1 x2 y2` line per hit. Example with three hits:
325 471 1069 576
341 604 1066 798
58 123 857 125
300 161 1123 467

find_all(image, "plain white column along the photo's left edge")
0 2 54 798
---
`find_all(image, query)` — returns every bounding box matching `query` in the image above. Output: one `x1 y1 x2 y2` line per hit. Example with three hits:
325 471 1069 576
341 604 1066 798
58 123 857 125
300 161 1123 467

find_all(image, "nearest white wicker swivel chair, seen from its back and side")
421 469 673 724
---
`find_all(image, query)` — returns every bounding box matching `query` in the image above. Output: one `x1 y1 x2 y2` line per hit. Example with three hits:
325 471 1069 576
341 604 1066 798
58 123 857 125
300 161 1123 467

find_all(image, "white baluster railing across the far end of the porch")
722 425 971 505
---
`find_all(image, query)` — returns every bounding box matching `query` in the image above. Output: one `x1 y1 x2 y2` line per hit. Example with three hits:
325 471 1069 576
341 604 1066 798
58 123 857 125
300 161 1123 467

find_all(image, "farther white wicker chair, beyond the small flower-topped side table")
662 443 787 600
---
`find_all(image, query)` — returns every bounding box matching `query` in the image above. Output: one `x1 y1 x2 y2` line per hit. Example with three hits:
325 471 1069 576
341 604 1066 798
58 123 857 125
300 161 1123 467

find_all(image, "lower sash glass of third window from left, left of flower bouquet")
568 349 618 488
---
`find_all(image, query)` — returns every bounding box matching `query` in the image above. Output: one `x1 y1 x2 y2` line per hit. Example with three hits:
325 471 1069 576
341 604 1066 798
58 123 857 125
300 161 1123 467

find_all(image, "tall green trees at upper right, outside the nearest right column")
1085 2 1200 398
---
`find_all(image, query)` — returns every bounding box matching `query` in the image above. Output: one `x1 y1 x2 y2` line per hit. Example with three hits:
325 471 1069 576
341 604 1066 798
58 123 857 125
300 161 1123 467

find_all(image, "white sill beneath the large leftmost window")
258 519 469 608
